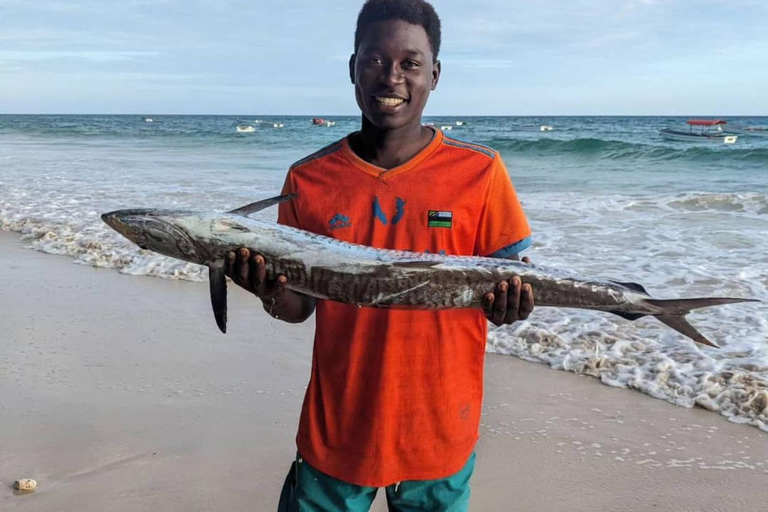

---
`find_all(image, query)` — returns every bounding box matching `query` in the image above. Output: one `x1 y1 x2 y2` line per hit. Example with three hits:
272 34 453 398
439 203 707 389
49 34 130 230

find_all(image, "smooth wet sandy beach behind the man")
0 232 768 512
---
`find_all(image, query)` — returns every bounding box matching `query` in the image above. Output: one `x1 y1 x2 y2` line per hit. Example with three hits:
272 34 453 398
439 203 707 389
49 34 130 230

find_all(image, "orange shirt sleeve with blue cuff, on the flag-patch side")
475 153 531 258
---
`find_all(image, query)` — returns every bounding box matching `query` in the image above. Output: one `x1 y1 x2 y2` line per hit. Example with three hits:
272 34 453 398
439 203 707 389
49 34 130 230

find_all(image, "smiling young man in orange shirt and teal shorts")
227 0 533 511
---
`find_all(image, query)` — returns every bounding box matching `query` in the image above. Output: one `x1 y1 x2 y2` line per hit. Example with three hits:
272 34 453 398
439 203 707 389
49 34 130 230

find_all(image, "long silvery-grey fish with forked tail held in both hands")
101 194 753 347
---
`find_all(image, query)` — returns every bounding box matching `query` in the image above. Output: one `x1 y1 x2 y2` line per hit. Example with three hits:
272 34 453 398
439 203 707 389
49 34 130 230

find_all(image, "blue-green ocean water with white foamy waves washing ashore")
0 115 768 430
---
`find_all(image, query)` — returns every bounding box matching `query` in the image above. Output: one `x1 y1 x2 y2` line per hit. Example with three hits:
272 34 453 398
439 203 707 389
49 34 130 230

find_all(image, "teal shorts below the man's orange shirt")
277 453 475 512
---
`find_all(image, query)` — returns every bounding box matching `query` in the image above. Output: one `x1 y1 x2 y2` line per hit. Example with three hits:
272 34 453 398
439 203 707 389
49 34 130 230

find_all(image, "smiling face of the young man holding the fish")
349 20 440 130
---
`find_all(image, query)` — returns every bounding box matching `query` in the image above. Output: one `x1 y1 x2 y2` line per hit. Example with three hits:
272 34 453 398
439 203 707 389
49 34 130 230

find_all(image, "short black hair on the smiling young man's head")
355 0 440 60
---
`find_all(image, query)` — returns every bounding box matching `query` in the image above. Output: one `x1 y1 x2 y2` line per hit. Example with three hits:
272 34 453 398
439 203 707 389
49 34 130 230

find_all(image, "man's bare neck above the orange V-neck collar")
350 117 435 169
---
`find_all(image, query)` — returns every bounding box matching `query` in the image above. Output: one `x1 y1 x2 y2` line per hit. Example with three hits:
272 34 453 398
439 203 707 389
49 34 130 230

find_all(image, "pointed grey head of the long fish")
101 209 205 264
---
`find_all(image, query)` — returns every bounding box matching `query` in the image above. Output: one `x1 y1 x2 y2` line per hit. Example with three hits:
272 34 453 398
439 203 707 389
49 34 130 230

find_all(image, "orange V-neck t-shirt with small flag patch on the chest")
278 127 530 487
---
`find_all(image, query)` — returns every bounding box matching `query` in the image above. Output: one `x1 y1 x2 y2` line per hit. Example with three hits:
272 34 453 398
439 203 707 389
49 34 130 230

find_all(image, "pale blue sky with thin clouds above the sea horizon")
0 0 768 116
